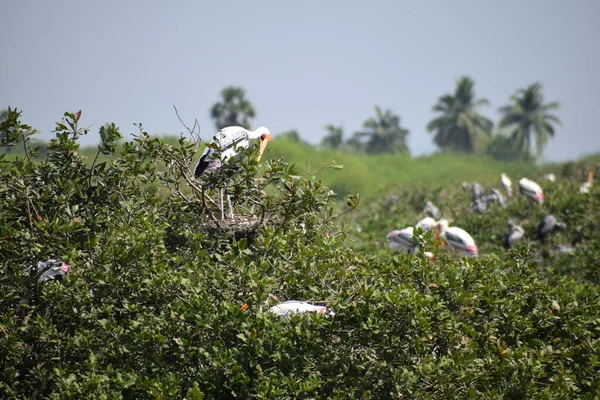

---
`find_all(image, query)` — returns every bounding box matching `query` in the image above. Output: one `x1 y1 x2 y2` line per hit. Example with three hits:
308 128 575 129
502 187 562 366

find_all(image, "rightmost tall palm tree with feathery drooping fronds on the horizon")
499 82 561 159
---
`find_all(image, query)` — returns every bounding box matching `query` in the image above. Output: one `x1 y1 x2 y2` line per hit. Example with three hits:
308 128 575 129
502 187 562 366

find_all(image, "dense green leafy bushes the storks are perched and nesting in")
0 108 600 399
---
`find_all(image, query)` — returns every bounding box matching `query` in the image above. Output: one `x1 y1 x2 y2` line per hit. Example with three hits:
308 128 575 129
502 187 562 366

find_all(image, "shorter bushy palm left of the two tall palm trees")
349 106 409 154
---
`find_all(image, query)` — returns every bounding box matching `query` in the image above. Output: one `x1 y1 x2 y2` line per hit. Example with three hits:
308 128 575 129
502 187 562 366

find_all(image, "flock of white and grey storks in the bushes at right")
386 172 593 260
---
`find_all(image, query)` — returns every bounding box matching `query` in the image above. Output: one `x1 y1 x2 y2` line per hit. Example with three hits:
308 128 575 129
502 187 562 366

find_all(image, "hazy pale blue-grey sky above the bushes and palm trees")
0 0 600 160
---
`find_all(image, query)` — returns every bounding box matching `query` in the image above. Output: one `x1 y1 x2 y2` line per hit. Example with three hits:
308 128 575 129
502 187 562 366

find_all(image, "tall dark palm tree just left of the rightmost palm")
427 76 493 152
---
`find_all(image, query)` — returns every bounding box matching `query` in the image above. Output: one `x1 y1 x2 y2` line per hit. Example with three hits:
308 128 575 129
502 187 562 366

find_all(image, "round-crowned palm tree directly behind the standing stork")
210 86 256 130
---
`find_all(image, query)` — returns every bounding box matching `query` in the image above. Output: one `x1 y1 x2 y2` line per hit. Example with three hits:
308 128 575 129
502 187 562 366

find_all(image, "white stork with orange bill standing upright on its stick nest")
194 126 272 219
